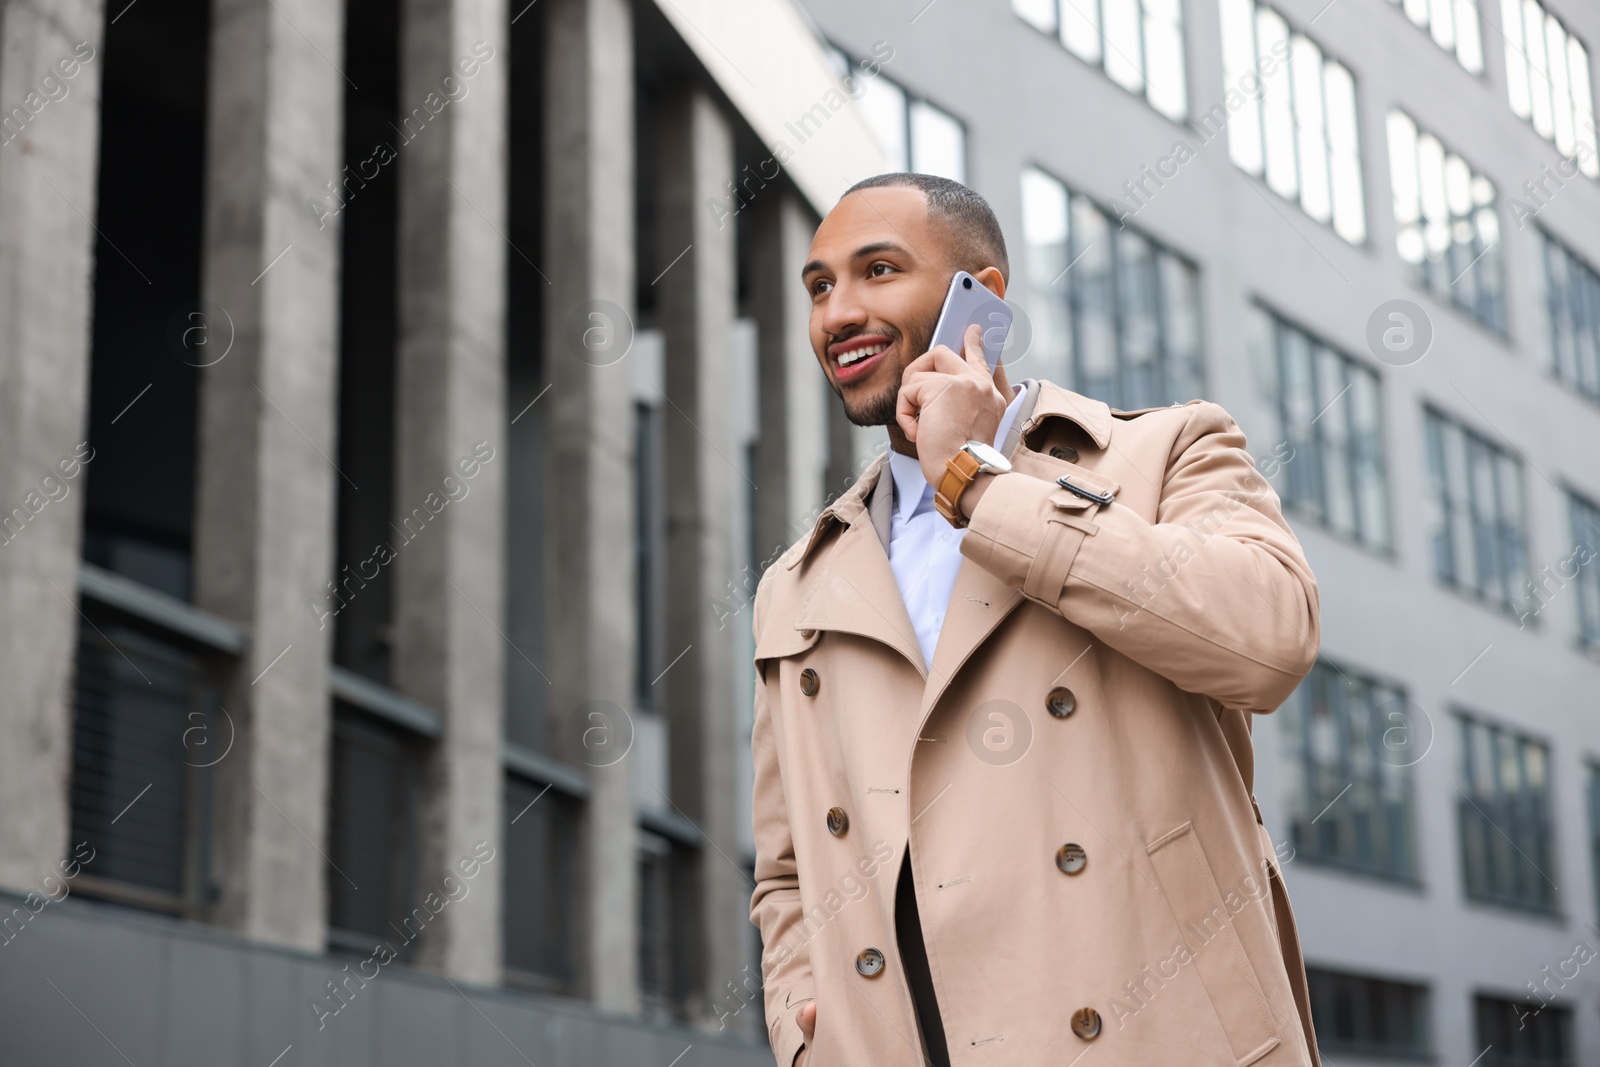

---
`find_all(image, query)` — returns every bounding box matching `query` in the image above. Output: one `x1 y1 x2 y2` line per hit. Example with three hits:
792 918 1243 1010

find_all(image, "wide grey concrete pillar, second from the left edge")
195 0 346 949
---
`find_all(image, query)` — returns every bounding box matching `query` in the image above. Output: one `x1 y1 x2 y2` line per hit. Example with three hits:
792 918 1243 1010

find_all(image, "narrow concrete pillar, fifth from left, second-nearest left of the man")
656 86 750 1022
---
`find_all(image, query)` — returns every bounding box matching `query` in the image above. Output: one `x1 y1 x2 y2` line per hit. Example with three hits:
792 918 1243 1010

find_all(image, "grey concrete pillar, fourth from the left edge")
539 0 638 1013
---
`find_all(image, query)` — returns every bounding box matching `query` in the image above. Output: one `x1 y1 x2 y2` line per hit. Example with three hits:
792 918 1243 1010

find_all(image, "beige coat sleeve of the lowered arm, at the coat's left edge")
750 587 816 1067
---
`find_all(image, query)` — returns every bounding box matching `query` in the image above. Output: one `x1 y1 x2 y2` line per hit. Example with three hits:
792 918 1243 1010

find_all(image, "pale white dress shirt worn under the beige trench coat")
890 384 1026 667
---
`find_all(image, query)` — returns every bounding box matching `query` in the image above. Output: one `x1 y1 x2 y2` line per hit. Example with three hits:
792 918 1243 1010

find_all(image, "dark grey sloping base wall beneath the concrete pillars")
0 893 771 1067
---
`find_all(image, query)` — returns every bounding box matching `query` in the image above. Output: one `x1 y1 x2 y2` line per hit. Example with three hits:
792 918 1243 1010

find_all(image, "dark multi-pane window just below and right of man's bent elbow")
1280 659 1418 881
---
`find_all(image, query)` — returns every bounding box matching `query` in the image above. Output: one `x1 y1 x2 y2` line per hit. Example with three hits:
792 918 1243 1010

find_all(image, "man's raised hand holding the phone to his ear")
894 316 1006 488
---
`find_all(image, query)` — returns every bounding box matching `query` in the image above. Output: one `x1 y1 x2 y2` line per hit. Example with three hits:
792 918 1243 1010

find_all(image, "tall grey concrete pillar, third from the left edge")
394 0 510 984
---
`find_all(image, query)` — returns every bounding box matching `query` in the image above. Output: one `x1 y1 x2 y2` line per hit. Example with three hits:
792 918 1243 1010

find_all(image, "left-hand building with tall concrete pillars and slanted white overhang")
0 0 885 1067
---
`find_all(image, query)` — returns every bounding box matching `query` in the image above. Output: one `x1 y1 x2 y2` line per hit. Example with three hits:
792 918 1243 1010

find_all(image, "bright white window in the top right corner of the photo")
1501 0 1600 178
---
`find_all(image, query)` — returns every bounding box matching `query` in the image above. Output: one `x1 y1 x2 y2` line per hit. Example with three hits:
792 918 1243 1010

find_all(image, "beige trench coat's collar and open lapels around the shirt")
787 379 1112 710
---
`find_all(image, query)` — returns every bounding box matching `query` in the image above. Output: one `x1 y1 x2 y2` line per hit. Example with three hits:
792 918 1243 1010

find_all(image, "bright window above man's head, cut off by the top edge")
1011 0 1189 122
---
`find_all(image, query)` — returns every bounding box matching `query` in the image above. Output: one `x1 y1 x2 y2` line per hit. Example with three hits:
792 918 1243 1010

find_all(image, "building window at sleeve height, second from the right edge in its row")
1424 408 1528 613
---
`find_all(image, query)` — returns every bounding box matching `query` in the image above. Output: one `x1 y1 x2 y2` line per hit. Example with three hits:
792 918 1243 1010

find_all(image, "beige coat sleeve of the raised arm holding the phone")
962 402 1320 712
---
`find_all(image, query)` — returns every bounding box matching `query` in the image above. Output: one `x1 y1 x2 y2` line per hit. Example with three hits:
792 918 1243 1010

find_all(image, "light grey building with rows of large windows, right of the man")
805 0 1600 1065
